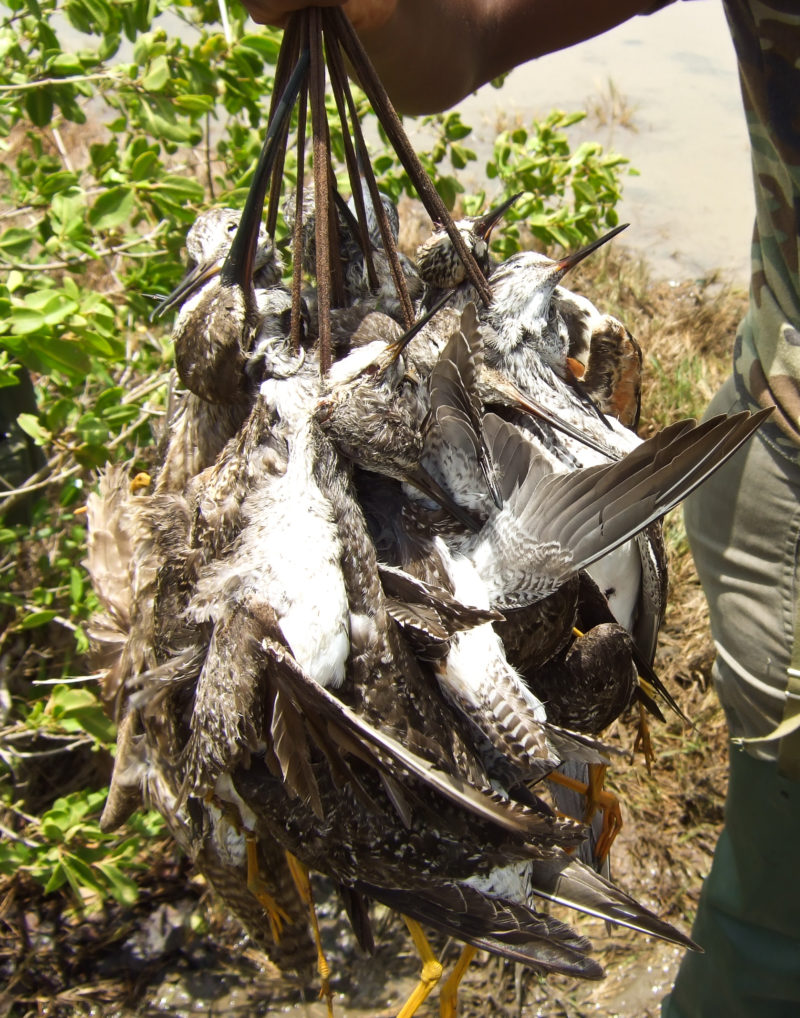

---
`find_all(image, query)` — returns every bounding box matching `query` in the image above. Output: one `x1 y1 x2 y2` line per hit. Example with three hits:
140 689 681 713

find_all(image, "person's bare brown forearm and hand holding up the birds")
243 0 653 113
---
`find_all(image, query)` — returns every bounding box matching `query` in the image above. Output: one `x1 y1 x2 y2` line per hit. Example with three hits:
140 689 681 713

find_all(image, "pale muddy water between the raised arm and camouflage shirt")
451 0 753 284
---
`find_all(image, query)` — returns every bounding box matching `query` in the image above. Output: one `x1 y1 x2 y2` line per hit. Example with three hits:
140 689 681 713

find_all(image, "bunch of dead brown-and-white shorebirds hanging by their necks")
83 171 760 1014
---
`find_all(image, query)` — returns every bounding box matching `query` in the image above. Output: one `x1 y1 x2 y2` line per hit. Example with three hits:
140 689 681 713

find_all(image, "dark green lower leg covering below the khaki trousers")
662 747 800 1018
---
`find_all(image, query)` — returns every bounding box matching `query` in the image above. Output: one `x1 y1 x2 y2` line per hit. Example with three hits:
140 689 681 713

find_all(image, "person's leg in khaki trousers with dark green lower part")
662 381 800 1018
